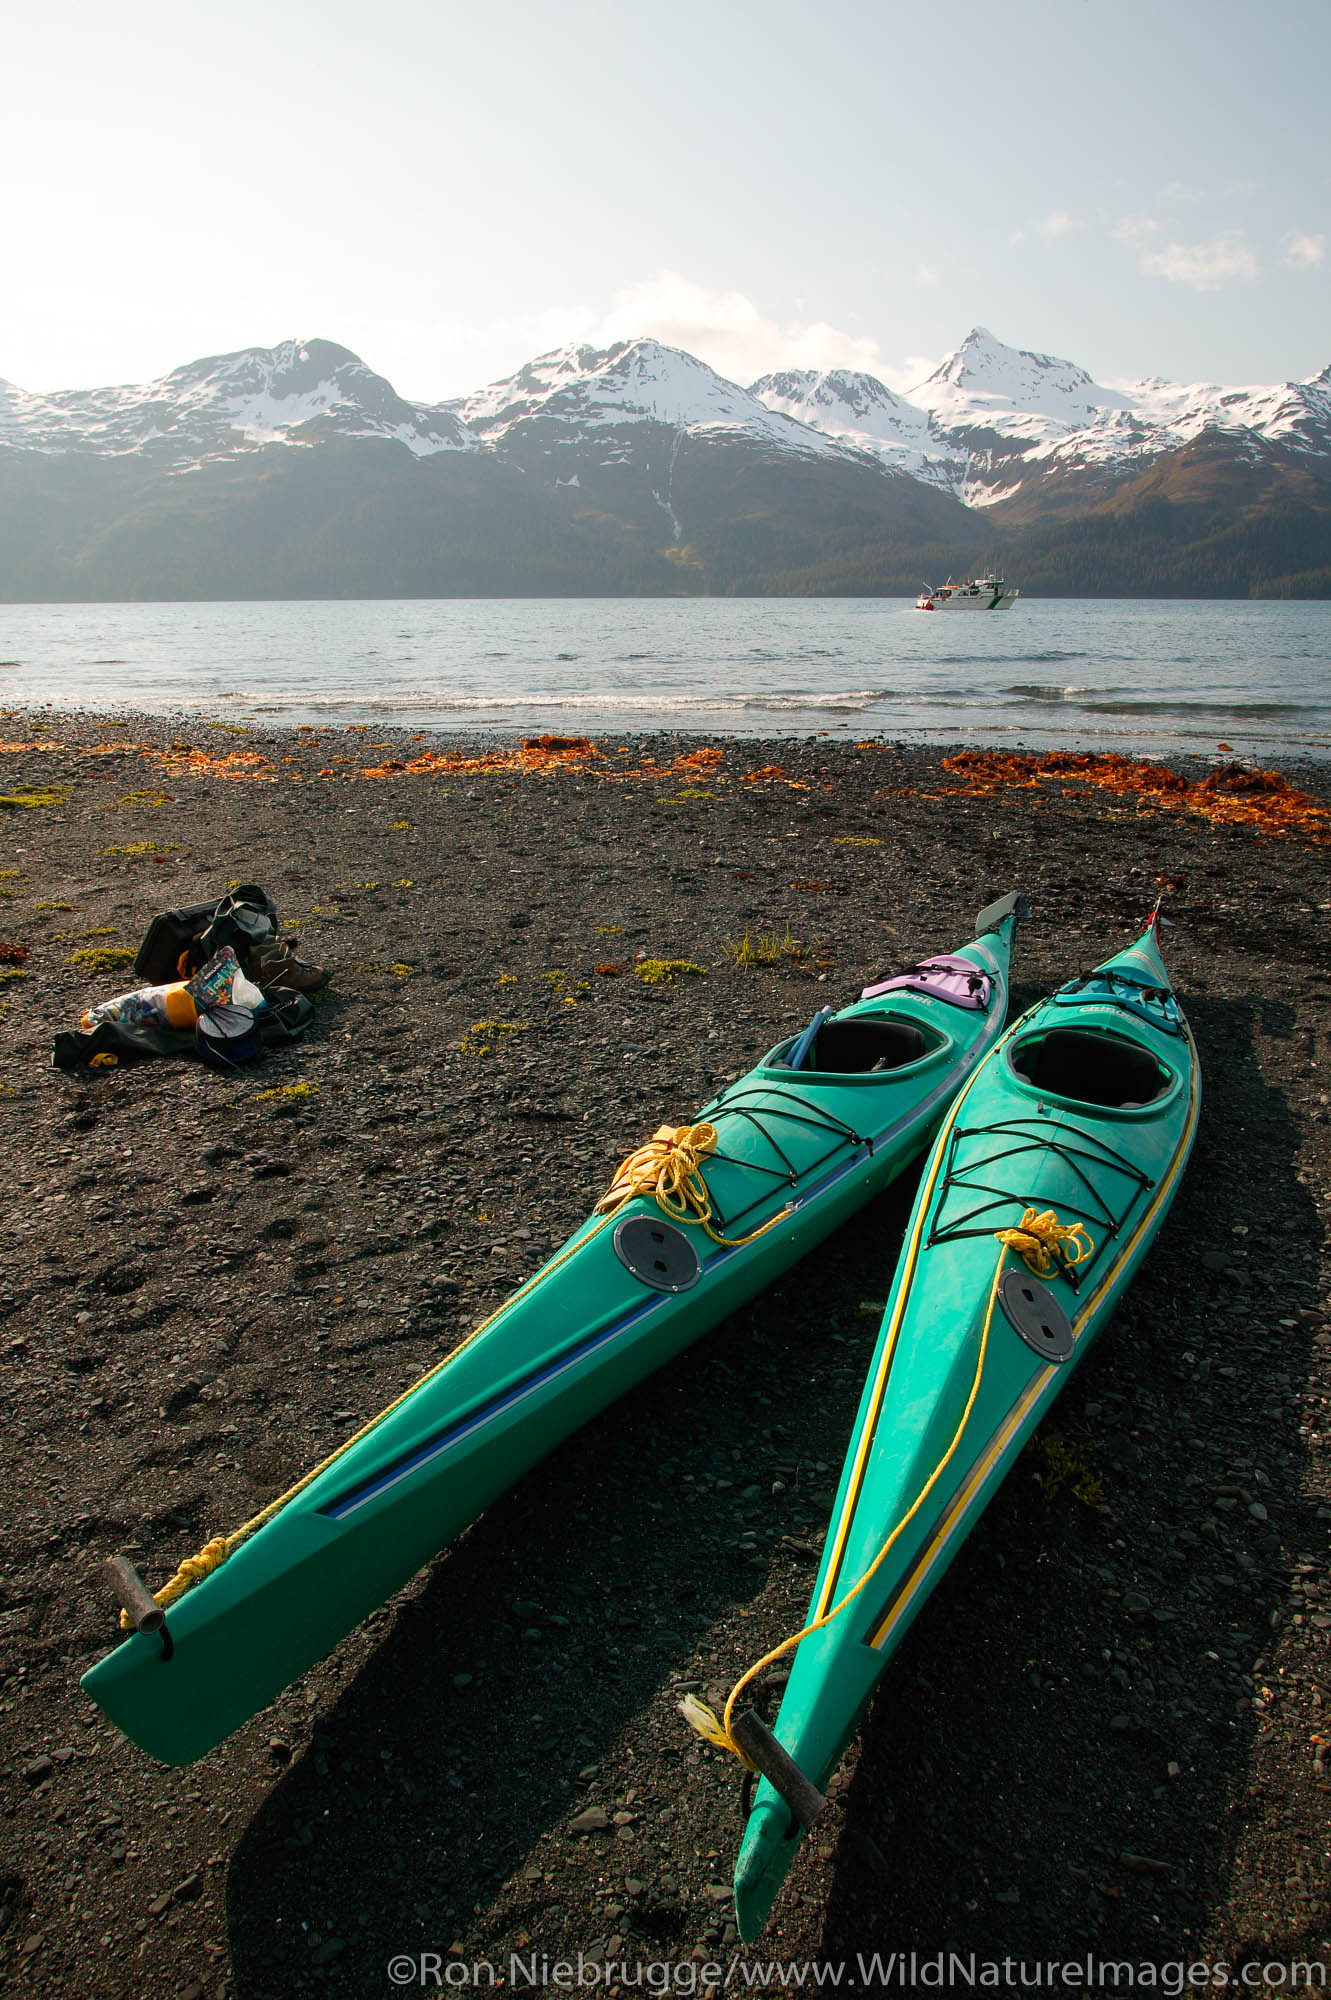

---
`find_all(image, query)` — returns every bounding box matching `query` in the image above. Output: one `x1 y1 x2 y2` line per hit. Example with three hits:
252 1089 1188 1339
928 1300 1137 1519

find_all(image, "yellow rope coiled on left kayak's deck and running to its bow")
120 1124 789 1632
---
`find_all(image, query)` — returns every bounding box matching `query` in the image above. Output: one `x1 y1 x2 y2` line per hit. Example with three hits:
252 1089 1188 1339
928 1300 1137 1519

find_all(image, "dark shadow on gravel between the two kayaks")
228 1170 915 2000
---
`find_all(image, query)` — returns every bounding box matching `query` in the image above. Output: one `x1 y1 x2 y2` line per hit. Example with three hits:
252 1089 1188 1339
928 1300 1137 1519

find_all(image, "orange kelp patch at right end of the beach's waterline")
933 750 1331 846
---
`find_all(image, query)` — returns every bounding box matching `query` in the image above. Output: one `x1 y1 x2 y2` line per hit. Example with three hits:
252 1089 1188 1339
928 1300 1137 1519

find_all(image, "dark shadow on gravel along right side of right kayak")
807 998 1327 1990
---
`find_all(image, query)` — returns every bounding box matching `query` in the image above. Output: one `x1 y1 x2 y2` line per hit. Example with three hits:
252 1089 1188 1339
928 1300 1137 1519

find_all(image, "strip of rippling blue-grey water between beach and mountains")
0 598 1331 758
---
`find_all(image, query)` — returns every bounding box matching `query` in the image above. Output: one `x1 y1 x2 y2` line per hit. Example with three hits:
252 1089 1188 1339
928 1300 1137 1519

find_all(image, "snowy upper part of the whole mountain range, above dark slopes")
10 326 1331 512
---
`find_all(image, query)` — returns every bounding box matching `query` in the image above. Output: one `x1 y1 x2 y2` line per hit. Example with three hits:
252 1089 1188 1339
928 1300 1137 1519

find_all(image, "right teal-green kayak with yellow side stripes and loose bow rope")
731 920 1201 1942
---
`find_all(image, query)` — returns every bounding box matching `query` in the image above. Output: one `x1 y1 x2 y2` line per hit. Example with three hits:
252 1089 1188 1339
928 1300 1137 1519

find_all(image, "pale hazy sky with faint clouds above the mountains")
0 0 1331 398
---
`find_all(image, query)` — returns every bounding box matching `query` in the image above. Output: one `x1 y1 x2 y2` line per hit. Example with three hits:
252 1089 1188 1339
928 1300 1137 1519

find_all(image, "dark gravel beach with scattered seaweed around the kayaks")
0 710 1331 2000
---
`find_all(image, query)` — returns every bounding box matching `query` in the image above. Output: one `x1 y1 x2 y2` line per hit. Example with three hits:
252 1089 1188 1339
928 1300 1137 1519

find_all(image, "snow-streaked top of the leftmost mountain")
0 340 476 470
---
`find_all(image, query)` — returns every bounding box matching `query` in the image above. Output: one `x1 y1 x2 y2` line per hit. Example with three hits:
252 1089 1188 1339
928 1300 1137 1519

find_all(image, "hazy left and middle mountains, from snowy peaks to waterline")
0 340 981 600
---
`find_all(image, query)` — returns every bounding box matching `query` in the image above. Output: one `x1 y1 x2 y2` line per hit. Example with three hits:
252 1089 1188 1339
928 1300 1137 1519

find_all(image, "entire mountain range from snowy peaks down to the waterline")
0 326 1331 600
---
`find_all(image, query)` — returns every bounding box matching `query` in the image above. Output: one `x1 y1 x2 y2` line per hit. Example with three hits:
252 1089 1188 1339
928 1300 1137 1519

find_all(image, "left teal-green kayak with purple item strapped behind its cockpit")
82 896 1019 1764
